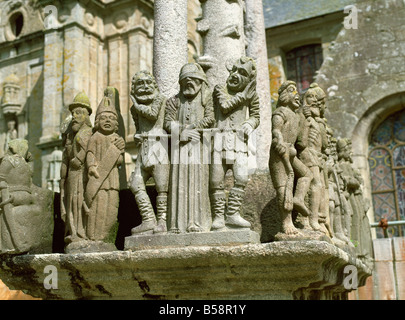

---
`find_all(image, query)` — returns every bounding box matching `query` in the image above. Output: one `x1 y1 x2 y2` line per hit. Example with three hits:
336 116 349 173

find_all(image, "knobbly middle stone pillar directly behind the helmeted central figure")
197 0 246 87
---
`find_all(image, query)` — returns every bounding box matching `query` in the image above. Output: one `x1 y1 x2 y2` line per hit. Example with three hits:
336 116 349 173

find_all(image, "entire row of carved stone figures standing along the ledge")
0 57 371 259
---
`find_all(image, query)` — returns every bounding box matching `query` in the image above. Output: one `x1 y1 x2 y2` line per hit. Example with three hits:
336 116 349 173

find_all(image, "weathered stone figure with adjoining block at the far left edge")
0 139 53 254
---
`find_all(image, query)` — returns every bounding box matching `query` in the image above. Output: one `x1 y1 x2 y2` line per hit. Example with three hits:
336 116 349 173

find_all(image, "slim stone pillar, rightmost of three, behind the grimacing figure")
245 0 272 171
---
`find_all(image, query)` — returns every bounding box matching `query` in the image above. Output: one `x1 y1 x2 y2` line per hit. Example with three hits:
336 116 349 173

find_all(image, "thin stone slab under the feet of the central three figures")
125 230 260 251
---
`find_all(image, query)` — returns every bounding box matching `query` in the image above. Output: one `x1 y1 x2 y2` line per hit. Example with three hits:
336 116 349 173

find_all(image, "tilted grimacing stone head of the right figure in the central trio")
226 57 257 93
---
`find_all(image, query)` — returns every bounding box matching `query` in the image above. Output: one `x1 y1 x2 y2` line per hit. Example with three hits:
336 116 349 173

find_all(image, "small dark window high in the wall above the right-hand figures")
286 44 323 93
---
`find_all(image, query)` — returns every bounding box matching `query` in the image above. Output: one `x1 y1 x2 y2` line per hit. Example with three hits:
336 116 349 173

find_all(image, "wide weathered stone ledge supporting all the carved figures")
0 240 371 300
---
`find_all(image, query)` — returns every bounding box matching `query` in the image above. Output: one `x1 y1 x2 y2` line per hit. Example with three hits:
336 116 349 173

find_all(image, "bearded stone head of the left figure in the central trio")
131 71 159 104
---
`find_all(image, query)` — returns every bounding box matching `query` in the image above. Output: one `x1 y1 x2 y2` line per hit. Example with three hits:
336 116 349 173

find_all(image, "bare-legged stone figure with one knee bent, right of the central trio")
269 81 313 237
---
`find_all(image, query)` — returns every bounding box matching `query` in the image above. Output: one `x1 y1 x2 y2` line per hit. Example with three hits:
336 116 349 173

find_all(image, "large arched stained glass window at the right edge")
368 111 405 237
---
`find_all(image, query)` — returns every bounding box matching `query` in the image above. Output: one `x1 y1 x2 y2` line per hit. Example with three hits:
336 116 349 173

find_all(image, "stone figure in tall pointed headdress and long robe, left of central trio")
85 89 125 241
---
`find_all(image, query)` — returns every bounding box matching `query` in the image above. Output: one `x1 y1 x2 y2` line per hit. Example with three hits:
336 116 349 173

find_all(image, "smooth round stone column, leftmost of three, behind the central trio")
153 0 187 97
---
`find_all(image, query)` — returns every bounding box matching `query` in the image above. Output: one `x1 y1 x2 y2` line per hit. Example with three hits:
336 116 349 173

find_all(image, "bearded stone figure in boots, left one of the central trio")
129 71 170 235
